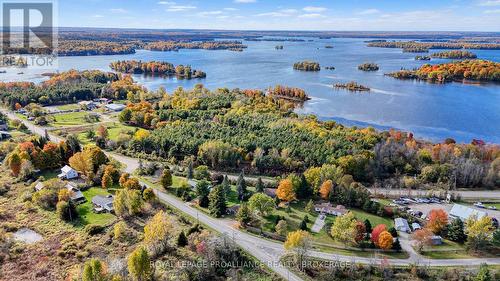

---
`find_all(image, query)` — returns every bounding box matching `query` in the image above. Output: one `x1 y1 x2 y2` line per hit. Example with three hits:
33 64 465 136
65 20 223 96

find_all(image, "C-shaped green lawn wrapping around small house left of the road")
77 187 116 226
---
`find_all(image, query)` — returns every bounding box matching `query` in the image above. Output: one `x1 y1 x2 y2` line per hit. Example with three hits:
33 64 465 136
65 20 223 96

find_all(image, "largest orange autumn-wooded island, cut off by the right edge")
387 60 500 83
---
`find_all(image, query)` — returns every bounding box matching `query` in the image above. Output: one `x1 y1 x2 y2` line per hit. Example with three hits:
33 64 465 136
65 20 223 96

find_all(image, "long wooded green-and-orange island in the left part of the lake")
110 60 207 79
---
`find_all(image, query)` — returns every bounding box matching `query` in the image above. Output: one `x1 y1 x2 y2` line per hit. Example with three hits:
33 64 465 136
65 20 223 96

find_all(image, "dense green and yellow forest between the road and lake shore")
109 85 500 188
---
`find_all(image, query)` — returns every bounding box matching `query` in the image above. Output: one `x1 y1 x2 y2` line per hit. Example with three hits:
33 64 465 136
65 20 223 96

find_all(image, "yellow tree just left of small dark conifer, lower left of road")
144 211 172 254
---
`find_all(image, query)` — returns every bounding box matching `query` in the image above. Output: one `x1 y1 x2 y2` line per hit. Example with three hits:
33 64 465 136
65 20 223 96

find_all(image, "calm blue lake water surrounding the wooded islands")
0 38 500 143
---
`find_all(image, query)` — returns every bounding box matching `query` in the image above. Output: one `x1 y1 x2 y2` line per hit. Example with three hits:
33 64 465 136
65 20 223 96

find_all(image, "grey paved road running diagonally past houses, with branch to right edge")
4 109 500 276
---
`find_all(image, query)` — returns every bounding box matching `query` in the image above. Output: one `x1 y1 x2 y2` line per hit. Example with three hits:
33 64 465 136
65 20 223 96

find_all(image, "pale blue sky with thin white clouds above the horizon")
54 0 500 31
